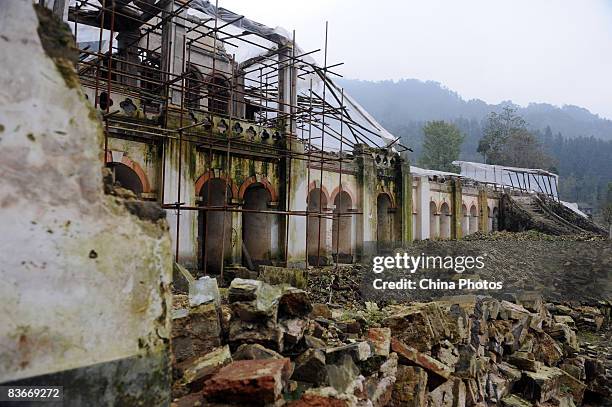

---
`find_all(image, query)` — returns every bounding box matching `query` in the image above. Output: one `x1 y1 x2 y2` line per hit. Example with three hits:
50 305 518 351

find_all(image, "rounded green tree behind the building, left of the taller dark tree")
419 121 465 172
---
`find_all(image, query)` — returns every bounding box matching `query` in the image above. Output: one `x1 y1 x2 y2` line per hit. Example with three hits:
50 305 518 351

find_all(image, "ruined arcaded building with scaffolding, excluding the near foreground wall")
57 1 512 275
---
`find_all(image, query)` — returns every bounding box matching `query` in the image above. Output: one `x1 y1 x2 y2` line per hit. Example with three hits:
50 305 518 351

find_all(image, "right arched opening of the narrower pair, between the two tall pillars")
332 191 353 263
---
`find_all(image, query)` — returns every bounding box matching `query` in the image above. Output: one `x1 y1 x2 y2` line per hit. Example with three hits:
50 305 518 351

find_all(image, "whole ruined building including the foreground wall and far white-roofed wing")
0 0 599 405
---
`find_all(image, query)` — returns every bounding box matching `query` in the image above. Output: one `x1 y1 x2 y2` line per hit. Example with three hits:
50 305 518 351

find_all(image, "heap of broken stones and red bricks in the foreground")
172 278 612 407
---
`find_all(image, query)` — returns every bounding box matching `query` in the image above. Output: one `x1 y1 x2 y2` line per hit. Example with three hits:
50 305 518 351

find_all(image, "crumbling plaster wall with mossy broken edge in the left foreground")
0 0 172 405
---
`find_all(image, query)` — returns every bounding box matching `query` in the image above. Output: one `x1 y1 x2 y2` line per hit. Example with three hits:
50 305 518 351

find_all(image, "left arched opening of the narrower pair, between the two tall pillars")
306 188 327 266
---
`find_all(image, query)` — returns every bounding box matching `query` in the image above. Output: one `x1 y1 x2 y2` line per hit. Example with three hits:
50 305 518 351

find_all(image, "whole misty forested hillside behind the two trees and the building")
338 79 612 208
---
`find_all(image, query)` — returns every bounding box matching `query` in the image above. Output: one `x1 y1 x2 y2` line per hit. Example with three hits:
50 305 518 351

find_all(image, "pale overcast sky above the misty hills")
224 0 612 119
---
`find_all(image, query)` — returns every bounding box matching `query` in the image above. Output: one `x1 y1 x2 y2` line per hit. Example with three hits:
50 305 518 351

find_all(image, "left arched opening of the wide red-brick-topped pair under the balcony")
198 178 232 274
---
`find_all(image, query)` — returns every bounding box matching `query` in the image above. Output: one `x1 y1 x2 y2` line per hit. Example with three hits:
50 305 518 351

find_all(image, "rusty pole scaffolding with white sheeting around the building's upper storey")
68 0 409 276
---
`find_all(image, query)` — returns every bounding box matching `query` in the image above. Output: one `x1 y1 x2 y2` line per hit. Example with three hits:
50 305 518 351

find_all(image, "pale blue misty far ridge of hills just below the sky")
338 79 612 140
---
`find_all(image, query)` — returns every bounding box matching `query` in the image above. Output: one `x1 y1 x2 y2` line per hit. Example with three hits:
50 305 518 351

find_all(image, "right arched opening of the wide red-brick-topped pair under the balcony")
242 182 274 267
